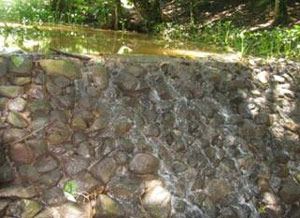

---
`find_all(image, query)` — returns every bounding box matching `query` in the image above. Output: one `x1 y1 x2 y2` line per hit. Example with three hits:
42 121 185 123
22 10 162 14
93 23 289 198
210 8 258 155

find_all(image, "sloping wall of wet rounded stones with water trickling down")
0 55 300 218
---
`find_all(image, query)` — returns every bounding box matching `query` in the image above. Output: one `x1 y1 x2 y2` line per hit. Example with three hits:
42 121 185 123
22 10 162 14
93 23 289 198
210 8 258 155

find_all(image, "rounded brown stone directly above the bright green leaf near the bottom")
65 155 89 176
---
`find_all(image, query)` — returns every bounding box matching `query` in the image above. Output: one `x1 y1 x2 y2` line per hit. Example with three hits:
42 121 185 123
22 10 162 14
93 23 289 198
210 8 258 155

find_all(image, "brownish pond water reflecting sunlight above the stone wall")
0 23 240 61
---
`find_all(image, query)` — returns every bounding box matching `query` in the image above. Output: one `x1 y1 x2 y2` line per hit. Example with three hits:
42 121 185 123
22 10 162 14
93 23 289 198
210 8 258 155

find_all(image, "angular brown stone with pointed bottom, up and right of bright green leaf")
91 157 117 184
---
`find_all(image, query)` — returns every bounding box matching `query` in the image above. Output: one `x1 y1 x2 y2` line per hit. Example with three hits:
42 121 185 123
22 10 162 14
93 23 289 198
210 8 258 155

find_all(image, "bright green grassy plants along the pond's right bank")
156 22 300 59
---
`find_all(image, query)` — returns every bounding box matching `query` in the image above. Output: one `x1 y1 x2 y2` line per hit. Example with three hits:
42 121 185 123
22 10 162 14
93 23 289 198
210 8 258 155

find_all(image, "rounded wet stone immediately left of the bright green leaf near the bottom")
42 187 66 206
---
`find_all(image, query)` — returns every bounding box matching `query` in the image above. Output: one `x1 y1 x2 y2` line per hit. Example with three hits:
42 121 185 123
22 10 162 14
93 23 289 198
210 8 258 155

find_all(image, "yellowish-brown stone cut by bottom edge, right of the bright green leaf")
94 195 125 218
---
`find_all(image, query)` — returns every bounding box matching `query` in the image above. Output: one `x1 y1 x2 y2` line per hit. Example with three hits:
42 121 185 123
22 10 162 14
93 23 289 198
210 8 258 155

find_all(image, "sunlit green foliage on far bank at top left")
0 0 116 26
